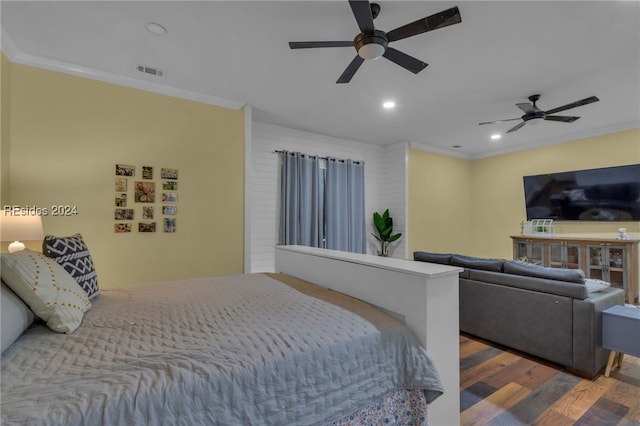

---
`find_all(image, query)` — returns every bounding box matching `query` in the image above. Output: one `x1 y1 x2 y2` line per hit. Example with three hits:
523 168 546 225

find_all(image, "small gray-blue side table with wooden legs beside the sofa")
602 305 640 377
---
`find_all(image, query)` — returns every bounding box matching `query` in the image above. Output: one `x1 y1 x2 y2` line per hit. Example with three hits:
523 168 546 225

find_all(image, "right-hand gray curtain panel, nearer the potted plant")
325 157 366 253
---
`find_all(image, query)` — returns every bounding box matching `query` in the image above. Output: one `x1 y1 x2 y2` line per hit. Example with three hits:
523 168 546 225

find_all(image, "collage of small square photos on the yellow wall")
113 164 178 234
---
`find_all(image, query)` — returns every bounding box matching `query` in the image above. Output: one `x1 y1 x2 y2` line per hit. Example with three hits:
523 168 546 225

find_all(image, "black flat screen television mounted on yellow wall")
523 164 640 222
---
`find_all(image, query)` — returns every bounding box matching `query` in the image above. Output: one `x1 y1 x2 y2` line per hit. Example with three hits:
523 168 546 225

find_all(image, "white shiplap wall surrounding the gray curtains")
246 122 406 272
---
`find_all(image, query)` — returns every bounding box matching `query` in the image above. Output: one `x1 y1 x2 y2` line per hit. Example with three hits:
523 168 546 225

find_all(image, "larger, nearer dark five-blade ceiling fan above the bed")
289 0 462 83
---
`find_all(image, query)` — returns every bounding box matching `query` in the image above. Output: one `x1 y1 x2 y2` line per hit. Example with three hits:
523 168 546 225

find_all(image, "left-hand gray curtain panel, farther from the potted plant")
278 151 324 247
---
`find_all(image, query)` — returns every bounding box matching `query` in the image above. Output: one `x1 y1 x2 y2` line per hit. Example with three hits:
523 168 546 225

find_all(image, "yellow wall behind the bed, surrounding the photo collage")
2 62 244 287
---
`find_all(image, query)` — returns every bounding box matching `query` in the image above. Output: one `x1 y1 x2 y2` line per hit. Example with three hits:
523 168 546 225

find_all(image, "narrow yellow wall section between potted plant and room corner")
407 149 472 257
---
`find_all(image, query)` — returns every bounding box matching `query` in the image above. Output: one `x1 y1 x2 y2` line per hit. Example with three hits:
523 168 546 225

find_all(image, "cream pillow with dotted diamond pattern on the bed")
1 250 91 333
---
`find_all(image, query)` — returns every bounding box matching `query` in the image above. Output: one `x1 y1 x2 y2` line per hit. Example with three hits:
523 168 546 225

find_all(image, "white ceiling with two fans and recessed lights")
0 0 640 158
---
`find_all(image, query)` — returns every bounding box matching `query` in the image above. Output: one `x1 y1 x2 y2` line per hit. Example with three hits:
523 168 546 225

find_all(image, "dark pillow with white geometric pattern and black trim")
42 234 100 299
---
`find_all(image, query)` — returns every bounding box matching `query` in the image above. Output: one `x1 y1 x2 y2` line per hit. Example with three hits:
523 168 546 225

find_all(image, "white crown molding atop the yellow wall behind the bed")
0 26 246 110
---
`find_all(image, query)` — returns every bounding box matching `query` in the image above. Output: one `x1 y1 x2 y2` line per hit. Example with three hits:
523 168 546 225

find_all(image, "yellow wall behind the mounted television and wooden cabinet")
470 129 640 257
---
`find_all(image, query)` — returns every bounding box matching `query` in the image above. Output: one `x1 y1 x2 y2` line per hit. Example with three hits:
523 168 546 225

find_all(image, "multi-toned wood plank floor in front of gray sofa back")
460 335 640 426
